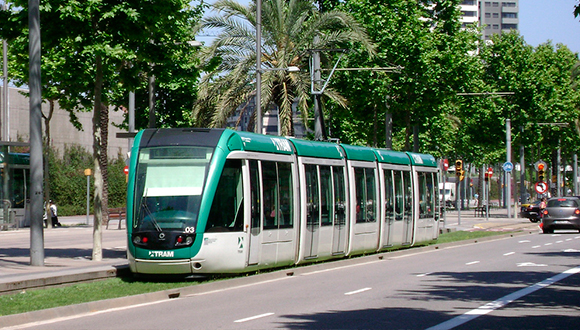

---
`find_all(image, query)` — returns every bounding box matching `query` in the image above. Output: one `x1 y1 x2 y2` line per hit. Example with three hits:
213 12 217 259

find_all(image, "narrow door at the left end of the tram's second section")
304 164 320 258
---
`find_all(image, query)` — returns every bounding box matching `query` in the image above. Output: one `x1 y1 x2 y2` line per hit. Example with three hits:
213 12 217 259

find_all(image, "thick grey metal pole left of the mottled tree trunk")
28 0 44 266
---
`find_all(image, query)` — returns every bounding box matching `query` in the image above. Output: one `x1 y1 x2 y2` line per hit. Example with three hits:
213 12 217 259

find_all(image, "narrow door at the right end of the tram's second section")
332 166 347 254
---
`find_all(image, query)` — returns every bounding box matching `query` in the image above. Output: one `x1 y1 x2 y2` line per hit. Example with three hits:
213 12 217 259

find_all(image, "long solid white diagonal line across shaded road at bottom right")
427 266 580 330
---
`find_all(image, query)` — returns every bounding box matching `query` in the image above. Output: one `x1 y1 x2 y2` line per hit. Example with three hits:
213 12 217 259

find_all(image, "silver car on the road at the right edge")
542 197 580 234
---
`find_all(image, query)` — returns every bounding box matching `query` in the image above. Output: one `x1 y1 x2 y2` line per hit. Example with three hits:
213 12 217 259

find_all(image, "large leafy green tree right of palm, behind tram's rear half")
333 0 481 156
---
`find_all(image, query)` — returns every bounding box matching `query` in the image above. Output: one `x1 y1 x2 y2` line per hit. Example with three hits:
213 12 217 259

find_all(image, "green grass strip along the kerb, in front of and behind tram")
0 231 507 316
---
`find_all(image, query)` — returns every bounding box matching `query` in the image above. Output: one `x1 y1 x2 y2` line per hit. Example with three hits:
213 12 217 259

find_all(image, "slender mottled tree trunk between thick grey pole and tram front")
93 55 104 261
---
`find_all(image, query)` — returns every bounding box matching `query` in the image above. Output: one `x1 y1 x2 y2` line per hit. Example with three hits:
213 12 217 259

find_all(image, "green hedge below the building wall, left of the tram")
49 145 127 216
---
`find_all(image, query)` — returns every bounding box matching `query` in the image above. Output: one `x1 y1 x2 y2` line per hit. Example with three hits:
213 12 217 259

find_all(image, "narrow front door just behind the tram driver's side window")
248 160 262 265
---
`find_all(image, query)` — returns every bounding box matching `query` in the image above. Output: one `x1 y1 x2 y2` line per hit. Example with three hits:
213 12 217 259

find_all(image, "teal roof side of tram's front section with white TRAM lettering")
224 129 294 155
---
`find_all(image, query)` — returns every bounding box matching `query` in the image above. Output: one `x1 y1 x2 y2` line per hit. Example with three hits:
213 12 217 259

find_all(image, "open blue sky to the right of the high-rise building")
519 0 580 53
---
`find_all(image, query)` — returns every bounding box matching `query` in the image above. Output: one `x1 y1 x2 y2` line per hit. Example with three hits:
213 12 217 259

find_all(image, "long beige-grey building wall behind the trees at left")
0 86 129 158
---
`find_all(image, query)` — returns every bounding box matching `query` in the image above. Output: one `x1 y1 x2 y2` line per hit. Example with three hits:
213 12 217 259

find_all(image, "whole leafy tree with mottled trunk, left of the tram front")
0 0 201 261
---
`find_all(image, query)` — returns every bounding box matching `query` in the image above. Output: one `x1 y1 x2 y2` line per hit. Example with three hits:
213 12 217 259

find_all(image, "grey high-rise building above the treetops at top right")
460 0 519 40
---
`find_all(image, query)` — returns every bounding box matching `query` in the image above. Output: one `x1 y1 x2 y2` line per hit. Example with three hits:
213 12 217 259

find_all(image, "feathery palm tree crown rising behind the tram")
192 0 374 135
